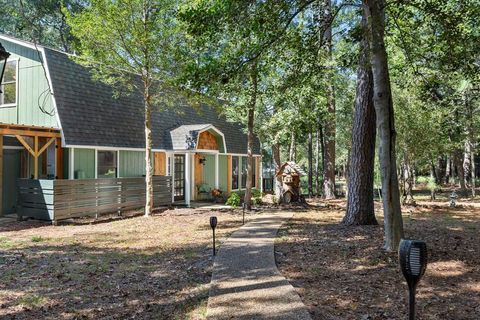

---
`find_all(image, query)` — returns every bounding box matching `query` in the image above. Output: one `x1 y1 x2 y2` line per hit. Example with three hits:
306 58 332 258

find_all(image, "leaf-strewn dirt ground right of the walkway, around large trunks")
275 199 480 320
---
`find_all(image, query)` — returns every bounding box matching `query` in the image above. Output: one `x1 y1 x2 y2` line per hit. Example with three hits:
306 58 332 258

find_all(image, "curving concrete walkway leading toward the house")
207 212 311 320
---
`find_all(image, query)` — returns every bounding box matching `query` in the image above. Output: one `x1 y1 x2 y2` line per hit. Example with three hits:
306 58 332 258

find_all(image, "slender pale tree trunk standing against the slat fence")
143 79 153 217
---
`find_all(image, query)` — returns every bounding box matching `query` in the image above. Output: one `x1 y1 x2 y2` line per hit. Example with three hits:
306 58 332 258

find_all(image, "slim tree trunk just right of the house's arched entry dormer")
244 61 258 210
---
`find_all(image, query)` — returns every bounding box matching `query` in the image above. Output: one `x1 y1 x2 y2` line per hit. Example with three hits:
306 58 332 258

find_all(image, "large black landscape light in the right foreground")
398 239 427 320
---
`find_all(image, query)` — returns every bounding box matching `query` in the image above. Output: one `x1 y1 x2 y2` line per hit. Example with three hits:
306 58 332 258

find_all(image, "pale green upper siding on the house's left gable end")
0 40 59 127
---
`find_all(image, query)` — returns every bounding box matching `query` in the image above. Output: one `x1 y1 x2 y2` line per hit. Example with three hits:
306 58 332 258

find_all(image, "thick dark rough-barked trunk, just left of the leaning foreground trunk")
342 17 378 225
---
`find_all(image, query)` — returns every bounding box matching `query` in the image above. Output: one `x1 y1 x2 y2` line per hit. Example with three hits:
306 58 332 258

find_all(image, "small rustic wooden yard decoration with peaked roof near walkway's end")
277 161 305 203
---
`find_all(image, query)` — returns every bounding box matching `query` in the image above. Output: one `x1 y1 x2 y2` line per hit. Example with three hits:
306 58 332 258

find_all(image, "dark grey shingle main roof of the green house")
45 48 260 154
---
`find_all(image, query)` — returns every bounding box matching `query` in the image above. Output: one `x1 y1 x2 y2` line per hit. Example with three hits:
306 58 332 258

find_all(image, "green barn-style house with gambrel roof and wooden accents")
0 35 261 215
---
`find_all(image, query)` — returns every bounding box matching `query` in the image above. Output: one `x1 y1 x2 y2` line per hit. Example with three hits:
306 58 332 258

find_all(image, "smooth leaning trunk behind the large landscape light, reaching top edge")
364 0 403 251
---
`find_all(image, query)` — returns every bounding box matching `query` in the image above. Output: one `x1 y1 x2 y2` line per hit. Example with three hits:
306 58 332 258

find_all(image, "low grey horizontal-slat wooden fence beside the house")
18 176 172 221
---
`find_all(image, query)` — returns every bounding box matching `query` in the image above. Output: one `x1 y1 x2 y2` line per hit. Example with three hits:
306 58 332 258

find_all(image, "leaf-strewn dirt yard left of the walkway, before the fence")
0 209 255 319
